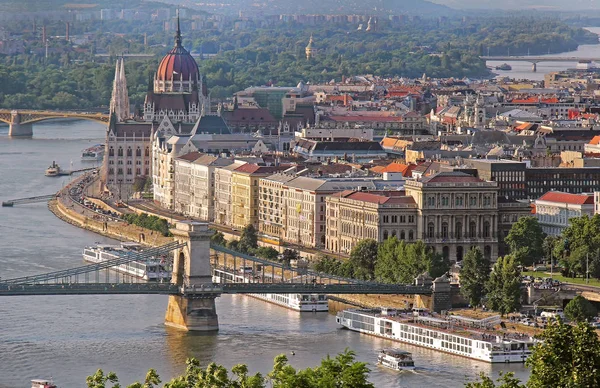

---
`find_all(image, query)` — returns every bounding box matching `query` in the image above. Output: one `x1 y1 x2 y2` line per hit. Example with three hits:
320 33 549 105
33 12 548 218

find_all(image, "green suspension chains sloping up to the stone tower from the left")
0 241 186 284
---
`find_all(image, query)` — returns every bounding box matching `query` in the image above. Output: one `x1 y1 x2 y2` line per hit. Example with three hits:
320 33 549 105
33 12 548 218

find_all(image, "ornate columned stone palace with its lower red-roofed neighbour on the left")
326 172 531 261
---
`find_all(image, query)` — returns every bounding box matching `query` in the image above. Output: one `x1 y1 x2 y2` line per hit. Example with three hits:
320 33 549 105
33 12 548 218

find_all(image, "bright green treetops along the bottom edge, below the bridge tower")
86 349 374 388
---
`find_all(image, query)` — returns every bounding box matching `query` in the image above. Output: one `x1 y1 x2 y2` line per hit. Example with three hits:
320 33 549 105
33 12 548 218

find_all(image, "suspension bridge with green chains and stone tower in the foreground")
0 221 435 331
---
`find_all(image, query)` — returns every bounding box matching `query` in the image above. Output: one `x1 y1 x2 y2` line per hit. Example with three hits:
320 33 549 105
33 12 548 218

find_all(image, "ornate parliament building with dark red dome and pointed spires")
102 17 229 202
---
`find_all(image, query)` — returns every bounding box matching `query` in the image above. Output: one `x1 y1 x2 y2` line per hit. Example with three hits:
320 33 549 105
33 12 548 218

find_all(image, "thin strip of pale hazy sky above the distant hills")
429 0 600 10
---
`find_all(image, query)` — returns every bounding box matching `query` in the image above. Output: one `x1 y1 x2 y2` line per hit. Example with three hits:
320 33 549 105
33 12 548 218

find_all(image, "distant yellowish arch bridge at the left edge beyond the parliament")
0 109 109 137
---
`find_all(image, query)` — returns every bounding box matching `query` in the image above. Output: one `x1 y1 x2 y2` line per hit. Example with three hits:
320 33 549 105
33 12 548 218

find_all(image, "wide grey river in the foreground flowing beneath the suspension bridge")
0 121 527 388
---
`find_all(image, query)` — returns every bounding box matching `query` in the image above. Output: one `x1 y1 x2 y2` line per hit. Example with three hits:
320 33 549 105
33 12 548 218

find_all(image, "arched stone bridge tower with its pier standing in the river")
165 221 219 331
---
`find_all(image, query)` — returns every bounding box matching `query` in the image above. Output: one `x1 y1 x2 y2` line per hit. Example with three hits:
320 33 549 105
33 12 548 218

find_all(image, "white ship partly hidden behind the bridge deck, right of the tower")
213 267 329 312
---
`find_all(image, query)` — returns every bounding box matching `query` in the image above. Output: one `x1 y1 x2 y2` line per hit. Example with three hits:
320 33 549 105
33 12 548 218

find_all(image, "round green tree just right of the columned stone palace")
504 217 546 265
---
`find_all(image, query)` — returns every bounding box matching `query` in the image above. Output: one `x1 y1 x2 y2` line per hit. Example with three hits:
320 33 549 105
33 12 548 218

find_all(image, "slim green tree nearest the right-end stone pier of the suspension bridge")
460 247 490 307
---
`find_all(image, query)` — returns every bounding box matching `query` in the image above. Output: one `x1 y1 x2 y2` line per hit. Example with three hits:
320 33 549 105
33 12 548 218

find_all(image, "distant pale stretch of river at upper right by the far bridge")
487 27 600 81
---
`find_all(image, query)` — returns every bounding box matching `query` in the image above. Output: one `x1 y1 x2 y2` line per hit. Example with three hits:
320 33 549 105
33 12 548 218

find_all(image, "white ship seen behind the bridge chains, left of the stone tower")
83 242 171 281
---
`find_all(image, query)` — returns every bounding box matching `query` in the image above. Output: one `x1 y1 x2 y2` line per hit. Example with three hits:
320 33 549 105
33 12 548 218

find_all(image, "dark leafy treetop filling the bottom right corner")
466 319 600 388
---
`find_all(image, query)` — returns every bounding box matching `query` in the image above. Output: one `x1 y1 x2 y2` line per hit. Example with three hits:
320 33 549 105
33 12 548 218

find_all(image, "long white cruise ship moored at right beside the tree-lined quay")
336 309 534 363
